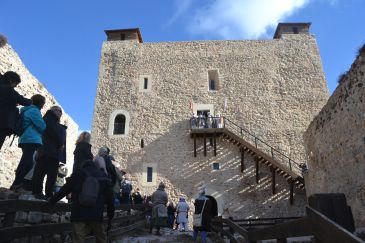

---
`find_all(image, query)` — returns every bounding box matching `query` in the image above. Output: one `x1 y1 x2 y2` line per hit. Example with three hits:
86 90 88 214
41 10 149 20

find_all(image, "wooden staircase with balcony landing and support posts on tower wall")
191 118 305 204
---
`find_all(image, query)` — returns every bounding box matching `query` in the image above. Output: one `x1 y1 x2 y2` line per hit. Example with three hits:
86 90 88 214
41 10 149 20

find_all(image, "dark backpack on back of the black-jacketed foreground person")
78 171 100 207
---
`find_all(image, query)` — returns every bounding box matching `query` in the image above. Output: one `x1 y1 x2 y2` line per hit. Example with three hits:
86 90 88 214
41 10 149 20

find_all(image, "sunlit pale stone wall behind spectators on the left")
0 44 78 187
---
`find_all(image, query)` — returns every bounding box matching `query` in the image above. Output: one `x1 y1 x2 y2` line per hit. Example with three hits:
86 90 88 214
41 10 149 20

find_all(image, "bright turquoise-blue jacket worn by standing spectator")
19 105 46 144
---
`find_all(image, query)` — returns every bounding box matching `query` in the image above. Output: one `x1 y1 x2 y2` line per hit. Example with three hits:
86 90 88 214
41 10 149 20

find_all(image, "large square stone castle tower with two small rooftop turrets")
92 23 329 218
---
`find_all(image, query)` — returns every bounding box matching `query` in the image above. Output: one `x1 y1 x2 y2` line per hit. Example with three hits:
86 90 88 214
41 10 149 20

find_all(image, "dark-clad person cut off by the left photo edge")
0 71 32 150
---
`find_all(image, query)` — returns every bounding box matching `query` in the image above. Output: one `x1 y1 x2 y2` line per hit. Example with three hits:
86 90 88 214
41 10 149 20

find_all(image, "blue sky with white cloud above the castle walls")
0 0 365 130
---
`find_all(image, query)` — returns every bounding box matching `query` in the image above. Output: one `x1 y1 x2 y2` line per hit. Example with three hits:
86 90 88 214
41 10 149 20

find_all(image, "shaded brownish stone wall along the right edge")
305 47 365 227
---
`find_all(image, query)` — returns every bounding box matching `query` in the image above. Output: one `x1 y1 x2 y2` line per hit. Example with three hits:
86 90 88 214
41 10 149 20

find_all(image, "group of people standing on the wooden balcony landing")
191 112 224 129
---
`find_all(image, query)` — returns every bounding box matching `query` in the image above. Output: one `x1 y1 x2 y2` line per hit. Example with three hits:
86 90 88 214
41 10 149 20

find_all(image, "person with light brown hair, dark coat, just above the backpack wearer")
72 132 94 173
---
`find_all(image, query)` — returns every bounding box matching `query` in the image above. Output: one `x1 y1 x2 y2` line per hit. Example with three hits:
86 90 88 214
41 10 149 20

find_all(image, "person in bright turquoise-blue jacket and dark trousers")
10 94 46 191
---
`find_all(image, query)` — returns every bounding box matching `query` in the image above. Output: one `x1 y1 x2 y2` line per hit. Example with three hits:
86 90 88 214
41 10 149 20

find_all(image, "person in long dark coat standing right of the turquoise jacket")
32 106 66 199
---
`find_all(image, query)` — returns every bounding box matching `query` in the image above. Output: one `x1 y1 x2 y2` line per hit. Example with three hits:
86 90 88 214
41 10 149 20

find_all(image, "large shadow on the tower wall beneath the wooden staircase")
126 119 306 218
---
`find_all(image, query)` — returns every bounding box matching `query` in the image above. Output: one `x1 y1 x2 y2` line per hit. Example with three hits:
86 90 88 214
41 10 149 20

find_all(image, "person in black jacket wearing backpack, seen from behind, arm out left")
49 160 114 242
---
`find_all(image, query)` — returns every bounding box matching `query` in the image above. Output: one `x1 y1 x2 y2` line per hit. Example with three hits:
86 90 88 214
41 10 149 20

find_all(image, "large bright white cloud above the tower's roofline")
188 0 310 39
